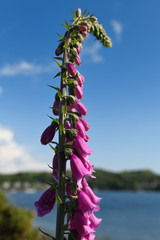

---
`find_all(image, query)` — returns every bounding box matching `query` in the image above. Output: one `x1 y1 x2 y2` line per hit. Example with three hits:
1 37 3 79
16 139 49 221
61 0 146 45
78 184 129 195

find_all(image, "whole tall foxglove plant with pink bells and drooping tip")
35 8 112 240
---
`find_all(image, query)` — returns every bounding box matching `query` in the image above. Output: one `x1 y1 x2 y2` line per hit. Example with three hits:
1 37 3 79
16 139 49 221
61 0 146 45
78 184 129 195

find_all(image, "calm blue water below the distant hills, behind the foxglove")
8 191 160 240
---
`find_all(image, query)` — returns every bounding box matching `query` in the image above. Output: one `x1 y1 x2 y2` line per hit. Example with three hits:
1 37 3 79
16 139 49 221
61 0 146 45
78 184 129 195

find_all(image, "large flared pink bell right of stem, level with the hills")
70 153 91 187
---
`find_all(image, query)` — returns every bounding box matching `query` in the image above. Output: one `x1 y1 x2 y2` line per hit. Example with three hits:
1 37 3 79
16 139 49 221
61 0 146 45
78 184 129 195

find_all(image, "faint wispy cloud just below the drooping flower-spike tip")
82 42 103 63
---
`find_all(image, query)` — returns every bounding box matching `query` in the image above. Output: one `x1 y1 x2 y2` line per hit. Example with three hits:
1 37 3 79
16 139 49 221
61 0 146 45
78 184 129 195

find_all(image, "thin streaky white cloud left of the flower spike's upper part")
0 61 55 76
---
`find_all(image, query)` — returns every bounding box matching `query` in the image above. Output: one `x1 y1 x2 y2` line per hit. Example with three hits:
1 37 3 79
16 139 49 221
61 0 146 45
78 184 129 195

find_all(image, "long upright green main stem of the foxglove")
56 32 71 240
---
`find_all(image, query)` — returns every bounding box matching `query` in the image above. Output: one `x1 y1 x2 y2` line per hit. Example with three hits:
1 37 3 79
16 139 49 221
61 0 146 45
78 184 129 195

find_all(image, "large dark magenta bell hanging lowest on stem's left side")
34 188 56 217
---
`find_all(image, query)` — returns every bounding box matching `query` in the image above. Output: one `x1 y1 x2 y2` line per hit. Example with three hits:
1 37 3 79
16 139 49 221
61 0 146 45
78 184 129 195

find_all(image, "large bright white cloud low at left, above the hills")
0 126 48 173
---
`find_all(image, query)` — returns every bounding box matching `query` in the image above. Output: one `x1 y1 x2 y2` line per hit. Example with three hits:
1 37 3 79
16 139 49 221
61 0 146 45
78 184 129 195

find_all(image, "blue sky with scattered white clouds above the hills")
0 0 160 173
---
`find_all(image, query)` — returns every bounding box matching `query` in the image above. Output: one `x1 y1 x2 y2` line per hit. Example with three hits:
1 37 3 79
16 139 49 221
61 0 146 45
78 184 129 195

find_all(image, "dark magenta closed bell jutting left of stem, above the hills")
41 125 56 145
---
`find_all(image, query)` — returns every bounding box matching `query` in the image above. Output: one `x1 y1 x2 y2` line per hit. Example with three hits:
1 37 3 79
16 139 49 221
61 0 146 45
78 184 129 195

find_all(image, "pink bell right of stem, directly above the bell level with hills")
73 134 93 158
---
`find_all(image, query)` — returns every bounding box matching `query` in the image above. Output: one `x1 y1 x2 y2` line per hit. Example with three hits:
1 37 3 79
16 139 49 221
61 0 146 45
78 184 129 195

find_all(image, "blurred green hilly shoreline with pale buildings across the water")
0 169 160 192
